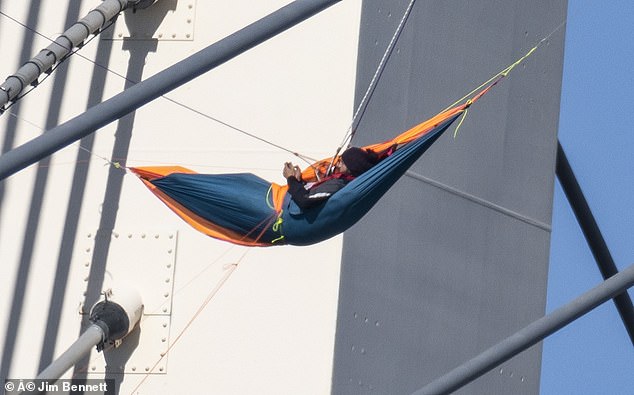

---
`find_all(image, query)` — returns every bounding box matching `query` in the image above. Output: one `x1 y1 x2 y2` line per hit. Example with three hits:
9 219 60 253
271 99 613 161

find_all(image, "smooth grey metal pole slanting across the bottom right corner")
414 265 634 395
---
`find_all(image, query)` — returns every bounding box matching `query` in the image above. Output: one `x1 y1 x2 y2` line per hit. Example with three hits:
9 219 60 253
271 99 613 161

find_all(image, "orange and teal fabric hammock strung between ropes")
131 89 488 246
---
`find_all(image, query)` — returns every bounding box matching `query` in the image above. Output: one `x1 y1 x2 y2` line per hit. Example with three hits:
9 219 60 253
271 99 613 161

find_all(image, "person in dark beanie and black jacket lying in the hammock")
282 147 379 210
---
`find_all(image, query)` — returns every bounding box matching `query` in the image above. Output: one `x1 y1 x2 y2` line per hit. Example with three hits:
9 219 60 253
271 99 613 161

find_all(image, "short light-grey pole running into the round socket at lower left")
36 324 106 382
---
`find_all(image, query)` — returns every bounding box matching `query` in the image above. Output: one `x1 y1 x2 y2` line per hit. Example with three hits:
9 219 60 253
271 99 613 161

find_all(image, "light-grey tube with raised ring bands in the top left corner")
0 0 149 110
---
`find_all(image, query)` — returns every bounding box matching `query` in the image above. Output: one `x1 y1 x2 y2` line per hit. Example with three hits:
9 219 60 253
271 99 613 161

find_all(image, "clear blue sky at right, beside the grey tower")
540 0 634 395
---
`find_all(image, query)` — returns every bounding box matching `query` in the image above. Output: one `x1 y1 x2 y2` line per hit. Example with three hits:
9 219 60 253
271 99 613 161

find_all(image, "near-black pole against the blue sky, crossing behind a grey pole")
556 141 634 345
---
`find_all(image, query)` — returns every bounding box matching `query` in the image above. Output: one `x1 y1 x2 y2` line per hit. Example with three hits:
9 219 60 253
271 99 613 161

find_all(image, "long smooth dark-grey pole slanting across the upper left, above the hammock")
0 0 341 180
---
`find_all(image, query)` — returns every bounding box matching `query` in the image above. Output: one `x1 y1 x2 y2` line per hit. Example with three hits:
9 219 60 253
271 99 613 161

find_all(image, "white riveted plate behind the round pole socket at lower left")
76 231 178 374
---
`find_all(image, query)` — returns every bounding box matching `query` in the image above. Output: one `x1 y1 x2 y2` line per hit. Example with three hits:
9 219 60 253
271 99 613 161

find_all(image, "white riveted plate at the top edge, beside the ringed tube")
113 0 196 41
